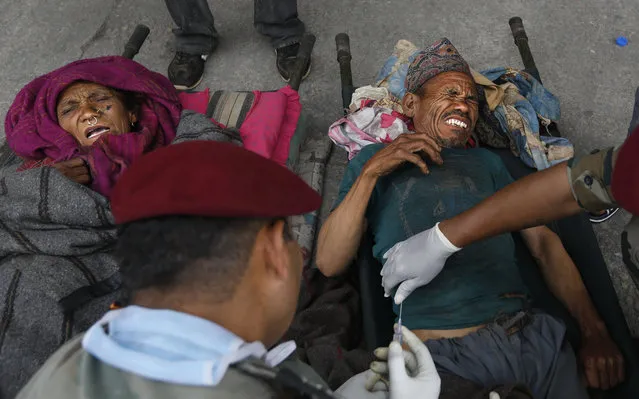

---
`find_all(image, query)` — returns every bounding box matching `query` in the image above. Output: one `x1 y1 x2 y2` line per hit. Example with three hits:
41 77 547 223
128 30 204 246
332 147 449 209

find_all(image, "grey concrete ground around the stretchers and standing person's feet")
0 0 639 336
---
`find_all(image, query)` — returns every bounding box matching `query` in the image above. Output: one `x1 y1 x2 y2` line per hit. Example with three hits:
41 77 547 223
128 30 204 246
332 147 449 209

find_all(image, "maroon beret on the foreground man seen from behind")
111 141 322 224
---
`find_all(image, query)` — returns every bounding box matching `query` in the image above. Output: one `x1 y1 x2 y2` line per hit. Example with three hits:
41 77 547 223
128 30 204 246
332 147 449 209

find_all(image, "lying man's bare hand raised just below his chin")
363 133 443 178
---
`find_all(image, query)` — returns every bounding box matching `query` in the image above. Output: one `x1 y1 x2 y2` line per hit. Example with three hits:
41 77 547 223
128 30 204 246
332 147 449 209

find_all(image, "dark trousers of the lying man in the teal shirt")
425 313 588 399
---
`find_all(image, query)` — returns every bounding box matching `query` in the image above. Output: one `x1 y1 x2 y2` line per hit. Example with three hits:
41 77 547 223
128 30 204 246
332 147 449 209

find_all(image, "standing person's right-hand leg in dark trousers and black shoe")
254 0 311 82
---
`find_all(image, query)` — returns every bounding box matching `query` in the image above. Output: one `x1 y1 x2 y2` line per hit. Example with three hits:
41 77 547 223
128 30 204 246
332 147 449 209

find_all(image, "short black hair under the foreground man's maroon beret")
115 216 291 300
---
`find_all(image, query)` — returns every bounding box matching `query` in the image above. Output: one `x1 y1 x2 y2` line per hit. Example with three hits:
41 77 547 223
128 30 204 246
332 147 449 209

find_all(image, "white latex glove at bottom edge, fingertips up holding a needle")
366 326 441 399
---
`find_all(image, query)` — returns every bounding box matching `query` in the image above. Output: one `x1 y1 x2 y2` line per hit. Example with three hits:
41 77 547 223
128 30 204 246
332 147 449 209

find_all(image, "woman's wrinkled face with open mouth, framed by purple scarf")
56 82 137 147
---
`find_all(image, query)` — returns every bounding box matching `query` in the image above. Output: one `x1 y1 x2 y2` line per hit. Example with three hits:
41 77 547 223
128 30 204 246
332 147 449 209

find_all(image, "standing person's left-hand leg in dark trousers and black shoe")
165 0 218 90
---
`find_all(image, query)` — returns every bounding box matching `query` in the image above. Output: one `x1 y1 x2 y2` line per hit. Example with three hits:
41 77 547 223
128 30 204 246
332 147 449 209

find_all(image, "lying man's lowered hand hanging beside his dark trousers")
579 332 626 389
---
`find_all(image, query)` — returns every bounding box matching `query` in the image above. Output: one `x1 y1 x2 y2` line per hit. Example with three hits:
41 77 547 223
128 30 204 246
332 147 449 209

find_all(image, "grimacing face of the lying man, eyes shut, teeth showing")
402 72 478 147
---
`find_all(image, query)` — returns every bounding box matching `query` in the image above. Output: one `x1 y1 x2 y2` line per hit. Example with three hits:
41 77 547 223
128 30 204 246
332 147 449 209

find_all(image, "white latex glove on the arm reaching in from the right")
381 223 461 305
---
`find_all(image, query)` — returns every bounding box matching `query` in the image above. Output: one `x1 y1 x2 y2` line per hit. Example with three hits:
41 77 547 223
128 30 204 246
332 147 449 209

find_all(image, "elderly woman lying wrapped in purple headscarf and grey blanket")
0 57 239 398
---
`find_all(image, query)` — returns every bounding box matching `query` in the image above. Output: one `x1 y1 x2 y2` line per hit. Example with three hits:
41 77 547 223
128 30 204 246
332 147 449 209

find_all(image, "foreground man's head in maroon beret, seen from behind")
111 141 321 346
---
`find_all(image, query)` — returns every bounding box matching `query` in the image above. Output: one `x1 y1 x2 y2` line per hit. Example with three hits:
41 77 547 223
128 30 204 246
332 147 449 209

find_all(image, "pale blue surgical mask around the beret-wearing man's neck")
82 306 295 386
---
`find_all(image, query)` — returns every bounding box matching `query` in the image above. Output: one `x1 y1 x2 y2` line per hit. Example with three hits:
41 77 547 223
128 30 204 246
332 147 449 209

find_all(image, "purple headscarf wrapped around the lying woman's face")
5 56 182 197
